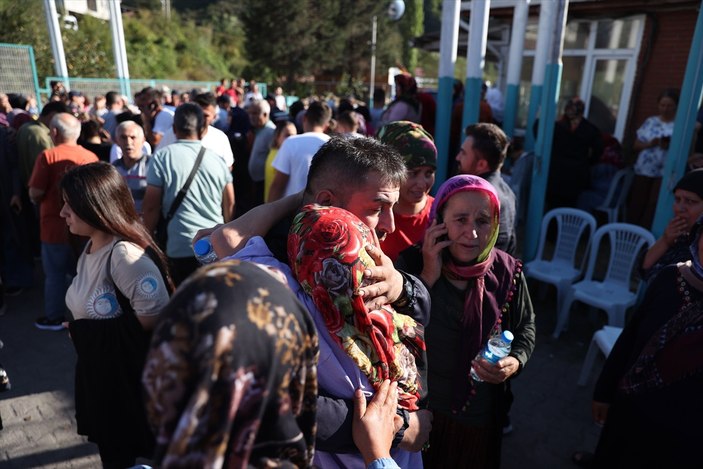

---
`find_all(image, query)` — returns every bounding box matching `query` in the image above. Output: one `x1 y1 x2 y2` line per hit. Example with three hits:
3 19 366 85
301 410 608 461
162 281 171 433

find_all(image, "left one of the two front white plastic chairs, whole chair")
524 207 597 311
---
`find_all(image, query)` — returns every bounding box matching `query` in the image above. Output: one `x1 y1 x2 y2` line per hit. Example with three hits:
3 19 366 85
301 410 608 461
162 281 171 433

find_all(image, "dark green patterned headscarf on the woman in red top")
376 121 437 169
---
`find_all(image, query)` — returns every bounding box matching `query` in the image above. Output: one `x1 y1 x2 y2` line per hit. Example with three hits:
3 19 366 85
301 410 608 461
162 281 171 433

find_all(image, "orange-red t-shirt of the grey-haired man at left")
29 143 98 243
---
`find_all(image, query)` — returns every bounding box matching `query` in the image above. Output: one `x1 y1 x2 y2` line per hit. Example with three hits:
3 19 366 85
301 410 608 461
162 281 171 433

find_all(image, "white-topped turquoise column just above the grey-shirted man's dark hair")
461 0 491 130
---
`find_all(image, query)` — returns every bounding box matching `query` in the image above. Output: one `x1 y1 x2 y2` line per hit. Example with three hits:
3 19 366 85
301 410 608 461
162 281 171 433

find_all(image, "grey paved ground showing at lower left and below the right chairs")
0 268 600 469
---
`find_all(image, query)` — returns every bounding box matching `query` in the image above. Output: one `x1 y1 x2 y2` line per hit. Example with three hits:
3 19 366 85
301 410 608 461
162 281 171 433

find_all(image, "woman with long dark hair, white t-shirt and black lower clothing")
60 163 172 467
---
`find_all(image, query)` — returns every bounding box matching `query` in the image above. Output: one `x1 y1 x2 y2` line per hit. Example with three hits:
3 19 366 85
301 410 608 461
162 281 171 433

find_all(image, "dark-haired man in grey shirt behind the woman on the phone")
456 123 517 255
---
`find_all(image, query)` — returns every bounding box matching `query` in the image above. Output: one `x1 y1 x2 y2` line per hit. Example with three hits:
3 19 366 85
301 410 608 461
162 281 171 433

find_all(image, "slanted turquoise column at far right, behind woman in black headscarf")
652 10 703 238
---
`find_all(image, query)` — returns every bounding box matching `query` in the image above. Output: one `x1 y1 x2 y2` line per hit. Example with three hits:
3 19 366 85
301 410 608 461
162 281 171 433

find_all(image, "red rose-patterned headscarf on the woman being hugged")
288 205 426 410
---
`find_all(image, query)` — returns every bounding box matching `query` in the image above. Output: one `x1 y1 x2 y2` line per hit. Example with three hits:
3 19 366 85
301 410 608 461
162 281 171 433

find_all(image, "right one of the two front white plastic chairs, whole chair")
552 223 655 338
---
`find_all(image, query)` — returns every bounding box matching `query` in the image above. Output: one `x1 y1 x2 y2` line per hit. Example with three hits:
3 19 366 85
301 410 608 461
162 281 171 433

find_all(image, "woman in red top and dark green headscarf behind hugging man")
377 121 437 262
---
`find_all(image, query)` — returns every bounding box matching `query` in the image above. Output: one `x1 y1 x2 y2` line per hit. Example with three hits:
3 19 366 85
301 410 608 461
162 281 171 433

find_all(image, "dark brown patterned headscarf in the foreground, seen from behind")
143 261 318 468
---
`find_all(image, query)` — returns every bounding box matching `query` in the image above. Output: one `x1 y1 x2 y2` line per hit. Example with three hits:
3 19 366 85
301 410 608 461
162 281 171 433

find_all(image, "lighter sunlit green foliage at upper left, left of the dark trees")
0 0 246 84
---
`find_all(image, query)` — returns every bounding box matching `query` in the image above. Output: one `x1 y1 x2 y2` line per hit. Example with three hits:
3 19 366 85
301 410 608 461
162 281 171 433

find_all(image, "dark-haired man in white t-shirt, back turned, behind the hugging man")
267 101 332 202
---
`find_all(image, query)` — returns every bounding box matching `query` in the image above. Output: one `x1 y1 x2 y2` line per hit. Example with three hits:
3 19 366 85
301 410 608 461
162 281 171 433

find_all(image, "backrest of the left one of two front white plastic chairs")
536 207 597 267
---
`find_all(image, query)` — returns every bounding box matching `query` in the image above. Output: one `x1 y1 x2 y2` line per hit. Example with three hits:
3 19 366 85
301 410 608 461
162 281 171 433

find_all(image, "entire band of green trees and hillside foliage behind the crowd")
0 0 434 97
